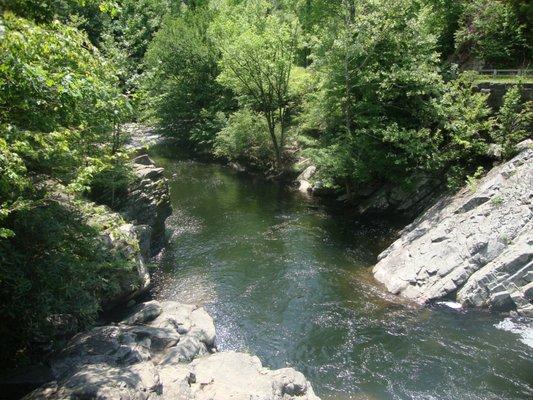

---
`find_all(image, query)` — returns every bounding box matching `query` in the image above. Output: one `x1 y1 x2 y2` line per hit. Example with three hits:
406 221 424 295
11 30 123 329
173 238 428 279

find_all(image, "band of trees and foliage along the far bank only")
145 0 530 188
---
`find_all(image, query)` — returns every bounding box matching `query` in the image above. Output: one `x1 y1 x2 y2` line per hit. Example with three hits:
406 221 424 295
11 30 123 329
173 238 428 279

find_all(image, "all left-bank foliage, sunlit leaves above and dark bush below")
0 4 135 366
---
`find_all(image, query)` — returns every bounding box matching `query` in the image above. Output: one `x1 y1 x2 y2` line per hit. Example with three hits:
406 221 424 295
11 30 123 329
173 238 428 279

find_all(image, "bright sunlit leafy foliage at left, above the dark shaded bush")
0 13 126 231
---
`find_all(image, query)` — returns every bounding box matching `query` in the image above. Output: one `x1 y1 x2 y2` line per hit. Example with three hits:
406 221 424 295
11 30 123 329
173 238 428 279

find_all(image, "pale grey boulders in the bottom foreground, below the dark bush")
25 301 318 400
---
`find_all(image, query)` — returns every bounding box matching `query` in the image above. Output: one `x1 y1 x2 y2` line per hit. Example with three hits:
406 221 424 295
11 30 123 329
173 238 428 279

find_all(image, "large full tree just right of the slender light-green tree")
302 0 443 192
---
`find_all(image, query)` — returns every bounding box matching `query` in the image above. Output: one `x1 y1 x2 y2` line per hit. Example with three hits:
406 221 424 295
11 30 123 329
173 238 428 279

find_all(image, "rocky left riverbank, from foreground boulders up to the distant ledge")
14 126 318 400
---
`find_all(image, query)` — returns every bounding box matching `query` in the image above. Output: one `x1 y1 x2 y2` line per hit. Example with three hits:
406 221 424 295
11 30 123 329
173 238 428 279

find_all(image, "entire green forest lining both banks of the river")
0 0 533 367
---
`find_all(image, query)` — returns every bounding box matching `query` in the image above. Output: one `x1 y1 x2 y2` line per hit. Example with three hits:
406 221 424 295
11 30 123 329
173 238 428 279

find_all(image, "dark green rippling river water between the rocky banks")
149 157 533 400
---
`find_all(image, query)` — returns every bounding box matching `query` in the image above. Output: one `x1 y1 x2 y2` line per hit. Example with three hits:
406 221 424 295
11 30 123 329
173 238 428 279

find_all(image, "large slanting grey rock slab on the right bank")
373 141 533 315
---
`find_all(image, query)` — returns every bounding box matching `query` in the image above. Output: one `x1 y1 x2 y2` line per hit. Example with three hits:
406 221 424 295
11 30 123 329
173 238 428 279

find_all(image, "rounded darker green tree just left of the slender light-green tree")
142 7 233 152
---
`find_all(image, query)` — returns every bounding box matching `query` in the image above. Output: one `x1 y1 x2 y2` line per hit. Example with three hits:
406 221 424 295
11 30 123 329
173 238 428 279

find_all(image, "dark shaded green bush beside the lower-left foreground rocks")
0 196 139 369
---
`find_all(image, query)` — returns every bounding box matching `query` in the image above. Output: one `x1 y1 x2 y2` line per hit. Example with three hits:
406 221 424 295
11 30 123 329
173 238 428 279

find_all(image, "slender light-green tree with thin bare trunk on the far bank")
214 0 299 169
